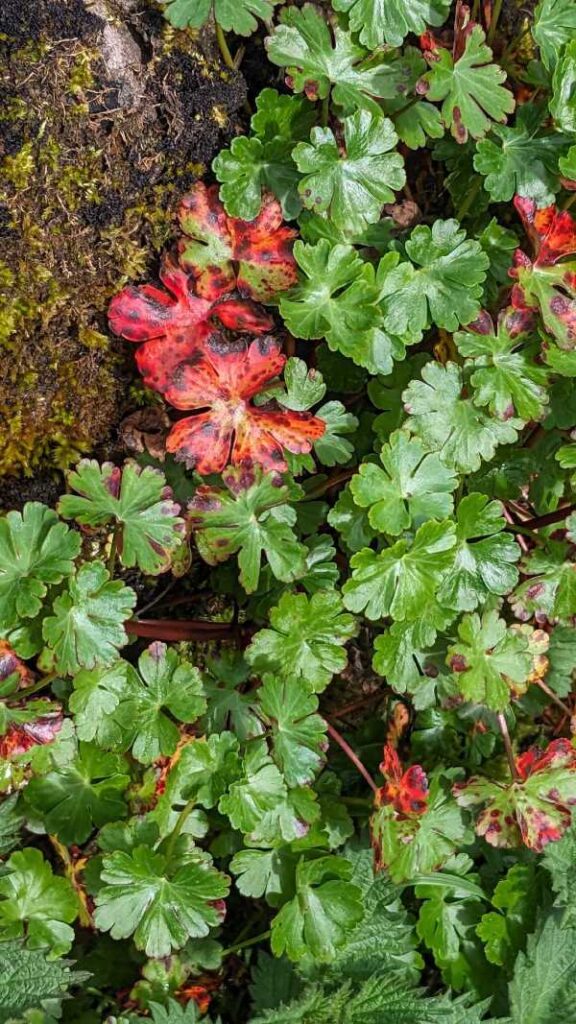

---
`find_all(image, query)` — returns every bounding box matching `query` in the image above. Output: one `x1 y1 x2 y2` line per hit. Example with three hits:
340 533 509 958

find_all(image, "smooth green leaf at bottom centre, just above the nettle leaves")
271 857 363 963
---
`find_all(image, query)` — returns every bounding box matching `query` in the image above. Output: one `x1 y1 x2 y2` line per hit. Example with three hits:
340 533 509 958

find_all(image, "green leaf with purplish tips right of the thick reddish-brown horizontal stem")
246 591 357 690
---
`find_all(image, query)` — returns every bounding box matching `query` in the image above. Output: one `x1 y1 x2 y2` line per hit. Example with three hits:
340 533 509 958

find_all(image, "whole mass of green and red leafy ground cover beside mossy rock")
0 0 576 1024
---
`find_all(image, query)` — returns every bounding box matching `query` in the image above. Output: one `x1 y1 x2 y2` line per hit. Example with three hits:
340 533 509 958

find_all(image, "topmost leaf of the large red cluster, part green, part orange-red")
178 181 297 302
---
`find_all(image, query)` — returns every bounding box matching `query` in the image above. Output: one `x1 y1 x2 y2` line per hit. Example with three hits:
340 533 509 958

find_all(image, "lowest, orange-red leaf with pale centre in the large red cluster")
165 335 325 475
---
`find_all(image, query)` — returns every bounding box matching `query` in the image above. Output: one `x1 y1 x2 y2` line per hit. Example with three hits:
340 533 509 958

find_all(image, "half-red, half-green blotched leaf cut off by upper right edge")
508 196 576 349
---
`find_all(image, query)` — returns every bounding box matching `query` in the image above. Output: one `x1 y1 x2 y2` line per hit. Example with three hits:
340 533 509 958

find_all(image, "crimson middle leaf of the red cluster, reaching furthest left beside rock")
108 254 273 393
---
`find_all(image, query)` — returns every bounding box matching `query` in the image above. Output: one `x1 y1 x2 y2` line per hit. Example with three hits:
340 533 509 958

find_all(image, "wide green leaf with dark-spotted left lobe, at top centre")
266 4 416 114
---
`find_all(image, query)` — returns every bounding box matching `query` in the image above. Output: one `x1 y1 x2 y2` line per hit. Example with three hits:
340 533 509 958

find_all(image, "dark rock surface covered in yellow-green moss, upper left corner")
0 0 245 475
